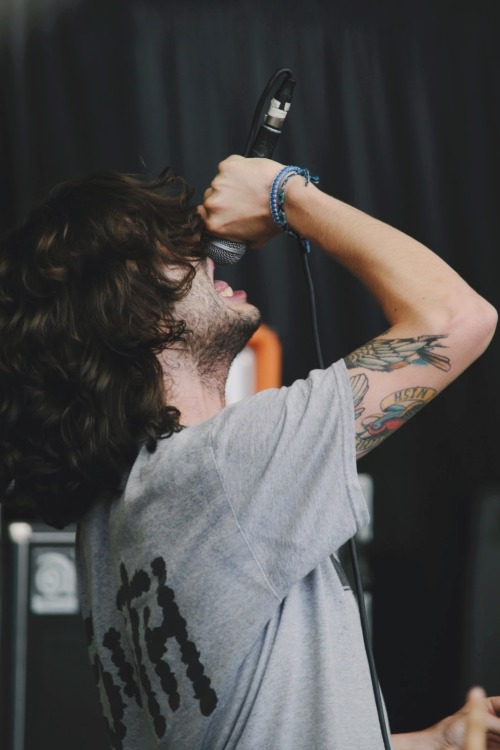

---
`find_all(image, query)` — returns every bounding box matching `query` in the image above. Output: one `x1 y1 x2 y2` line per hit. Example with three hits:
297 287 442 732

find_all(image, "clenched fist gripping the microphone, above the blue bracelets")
198 156 283 247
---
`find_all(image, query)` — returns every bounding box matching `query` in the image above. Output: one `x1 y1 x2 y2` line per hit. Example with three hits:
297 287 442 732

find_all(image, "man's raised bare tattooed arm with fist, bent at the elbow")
202 157 497 457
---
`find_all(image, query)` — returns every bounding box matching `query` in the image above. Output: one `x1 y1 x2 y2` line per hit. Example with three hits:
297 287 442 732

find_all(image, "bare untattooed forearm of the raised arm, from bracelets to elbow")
285 177 494 334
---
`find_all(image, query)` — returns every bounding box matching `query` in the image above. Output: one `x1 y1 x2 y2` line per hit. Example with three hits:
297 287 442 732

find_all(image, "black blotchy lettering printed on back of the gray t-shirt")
86 557 217 750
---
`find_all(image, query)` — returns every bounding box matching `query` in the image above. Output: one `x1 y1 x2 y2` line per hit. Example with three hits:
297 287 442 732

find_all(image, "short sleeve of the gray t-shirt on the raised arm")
211 360 368 598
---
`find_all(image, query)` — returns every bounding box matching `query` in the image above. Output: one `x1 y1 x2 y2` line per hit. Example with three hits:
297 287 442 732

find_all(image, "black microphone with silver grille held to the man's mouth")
207 75 295 265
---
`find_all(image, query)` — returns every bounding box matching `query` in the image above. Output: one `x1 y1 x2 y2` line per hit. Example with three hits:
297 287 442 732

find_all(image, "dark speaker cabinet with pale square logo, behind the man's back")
0 522 110 750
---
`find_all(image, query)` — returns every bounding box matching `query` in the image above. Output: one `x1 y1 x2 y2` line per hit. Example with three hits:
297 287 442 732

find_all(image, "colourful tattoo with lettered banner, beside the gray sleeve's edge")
351 384 437 455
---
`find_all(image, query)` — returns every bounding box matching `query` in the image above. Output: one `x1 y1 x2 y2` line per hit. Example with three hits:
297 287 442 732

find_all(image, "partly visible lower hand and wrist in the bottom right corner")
392 688 500 750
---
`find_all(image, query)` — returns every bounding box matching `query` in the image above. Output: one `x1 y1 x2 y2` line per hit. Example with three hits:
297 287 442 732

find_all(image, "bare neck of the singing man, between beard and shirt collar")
160 350 229 427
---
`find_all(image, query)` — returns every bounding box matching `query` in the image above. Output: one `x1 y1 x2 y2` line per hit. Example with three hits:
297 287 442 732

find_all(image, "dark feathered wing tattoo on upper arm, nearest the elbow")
344 335 451 372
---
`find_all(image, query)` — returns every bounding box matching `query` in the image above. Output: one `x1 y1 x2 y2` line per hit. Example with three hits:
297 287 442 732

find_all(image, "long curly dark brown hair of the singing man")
0 172 206 528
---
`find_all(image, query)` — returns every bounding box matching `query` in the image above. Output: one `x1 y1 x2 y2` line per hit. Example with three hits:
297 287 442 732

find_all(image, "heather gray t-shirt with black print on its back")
77 361 383 750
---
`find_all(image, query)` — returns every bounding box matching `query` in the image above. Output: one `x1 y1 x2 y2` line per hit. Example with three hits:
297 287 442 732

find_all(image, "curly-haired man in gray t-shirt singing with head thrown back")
0 157 500 750
